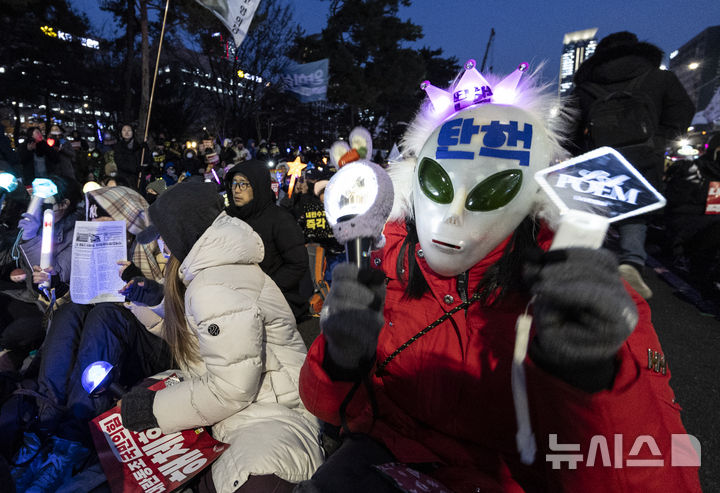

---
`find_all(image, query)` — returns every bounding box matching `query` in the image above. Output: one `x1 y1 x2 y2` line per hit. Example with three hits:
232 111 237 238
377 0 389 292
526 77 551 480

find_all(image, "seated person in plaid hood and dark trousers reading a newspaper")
12 187 172 491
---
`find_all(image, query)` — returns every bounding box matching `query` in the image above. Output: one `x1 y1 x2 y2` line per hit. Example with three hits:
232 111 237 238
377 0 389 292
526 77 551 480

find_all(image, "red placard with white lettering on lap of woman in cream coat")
90 377 229 493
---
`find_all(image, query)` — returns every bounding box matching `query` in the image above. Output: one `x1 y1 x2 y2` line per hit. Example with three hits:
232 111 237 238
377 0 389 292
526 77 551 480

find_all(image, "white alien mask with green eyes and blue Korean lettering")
413 104 550 276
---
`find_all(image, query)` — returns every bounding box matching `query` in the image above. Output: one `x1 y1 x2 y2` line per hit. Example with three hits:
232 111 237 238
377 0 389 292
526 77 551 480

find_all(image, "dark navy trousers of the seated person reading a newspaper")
38 303 172 441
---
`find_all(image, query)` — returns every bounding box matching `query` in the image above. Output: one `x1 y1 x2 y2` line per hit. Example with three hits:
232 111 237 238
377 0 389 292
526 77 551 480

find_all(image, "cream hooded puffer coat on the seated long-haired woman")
153 213 323 493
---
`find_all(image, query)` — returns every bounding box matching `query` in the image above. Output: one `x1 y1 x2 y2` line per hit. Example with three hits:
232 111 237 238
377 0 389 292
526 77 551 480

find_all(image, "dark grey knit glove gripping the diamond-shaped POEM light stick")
525 248 638 391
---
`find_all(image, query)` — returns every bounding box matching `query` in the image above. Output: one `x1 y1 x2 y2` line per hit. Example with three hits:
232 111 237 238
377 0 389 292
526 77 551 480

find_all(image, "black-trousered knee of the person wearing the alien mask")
295 435 398 493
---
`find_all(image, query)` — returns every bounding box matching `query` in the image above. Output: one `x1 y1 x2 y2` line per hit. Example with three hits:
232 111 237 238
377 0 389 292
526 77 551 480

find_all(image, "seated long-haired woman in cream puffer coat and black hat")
121 183 323 493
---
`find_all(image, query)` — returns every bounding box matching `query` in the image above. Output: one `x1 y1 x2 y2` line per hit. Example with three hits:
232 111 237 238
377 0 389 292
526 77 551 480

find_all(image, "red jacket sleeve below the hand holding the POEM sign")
526 292 701 492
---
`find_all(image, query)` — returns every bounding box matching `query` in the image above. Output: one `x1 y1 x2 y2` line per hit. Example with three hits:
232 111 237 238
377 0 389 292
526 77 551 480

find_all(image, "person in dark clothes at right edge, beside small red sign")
665 134 720 300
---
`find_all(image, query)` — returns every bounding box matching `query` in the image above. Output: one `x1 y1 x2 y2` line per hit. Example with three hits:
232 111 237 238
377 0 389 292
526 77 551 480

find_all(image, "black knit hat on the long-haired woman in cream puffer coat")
138 183 223 263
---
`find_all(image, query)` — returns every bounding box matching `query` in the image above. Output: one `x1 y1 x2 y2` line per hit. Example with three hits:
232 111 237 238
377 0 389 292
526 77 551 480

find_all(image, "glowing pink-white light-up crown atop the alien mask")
420 59 528 114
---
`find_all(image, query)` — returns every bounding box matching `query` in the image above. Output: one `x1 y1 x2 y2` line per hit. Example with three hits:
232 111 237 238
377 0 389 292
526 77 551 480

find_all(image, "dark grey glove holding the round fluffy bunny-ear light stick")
320 264 385 379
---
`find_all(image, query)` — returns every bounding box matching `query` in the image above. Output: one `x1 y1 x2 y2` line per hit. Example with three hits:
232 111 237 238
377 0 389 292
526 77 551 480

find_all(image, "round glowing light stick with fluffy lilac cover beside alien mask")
325 161 394 268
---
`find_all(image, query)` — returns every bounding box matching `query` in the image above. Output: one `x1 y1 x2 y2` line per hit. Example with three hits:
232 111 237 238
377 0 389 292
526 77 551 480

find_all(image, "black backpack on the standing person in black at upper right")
580 71 658 149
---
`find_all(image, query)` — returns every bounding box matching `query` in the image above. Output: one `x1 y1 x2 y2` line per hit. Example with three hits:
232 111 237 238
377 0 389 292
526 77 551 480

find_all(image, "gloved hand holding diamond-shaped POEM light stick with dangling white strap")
512 147 665 464
